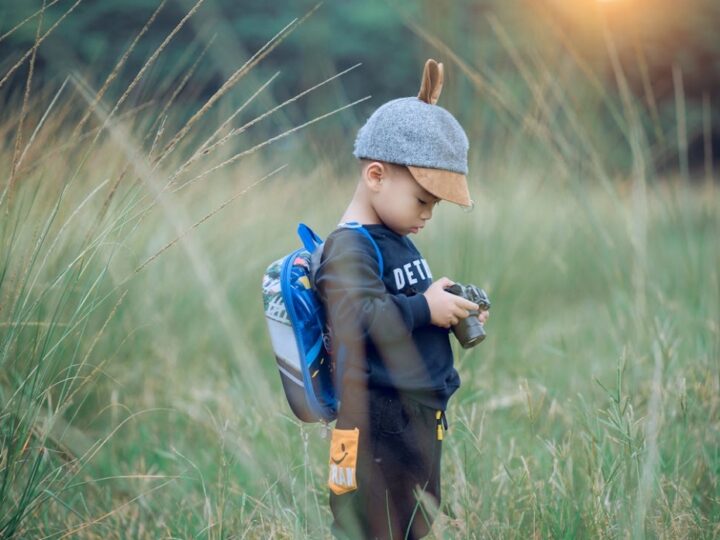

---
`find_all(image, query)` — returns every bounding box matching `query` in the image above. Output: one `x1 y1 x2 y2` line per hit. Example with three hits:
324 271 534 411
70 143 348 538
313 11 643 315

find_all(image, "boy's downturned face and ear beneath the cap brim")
365 162 440 236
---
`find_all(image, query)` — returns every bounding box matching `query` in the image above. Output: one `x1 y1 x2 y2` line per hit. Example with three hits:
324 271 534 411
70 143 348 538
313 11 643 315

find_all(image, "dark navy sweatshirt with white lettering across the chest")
314 224 460 410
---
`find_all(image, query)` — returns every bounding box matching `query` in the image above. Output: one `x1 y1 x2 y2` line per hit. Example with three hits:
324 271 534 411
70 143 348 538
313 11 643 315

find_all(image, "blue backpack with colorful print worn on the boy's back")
262 221 383 422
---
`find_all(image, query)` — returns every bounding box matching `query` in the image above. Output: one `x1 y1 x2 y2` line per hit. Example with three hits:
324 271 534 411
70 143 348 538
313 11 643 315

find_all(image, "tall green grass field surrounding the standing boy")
0 3 720 538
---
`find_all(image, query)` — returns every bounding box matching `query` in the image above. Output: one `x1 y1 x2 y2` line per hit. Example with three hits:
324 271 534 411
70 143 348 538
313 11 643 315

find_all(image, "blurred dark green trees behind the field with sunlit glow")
0 0 720 176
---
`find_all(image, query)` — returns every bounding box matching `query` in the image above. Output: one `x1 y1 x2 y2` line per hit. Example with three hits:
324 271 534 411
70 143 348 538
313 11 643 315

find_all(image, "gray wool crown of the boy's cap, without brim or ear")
353 97 469 174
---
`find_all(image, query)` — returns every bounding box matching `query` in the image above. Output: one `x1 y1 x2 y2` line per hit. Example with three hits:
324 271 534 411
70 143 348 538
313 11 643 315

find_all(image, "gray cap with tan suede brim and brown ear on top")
353 58 473 206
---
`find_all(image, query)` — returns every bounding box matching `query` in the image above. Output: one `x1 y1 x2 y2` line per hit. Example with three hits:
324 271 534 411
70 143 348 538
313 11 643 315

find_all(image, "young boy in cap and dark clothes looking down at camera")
313 59 488 539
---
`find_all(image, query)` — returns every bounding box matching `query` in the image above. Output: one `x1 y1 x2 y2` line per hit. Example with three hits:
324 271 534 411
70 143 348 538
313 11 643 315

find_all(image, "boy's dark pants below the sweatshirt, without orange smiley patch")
329 390 442 540
